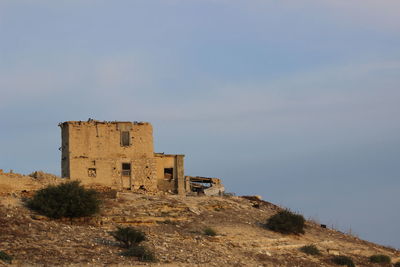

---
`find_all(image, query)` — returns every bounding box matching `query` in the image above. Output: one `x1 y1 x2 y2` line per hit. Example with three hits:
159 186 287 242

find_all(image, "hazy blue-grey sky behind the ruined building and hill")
0 0 400 248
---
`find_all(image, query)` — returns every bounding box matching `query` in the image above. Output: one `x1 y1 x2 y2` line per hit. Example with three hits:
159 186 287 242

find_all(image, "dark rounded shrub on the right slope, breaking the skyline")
265 210 305 234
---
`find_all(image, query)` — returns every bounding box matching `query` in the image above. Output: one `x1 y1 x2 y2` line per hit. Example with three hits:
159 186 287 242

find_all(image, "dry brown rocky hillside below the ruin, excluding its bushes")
0 174 400 267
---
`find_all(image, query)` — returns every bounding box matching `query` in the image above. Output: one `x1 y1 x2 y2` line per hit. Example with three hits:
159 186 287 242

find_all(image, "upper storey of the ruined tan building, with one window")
60 120 154 162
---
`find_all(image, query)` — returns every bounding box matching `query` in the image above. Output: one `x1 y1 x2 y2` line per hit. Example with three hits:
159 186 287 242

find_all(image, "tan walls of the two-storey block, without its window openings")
60 121 157 191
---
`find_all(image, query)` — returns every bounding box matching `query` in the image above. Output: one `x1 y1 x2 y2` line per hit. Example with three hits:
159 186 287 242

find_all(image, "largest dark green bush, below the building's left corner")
26 181 100 219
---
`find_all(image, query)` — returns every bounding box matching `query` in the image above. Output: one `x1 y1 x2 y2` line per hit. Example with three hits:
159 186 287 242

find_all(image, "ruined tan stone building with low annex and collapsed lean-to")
59 119 224 194
